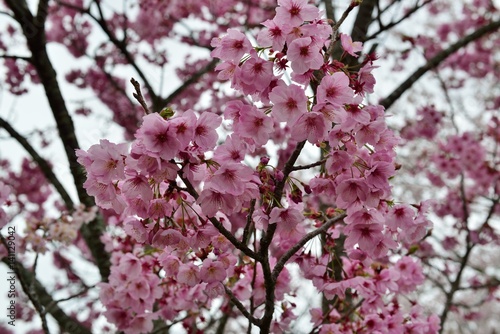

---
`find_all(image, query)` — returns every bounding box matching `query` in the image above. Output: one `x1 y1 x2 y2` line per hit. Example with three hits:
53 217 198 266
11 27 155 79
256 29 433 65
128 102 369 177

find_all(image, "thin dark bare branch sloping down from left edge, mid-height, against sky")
0 117 74 207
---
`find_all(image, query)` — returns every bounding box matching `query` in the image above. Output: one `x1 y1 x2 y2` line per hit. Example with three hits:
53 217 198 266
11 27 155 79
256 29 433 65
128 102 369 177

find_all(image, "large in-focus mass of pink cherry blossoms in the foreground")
77 0 436 333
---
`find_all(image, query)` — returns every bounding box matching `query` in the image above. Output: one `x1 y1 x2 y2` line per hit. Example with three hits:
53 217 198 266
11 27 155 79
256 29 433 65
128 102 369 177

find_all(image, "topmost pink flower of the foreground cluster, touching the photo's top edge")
275 0 319 27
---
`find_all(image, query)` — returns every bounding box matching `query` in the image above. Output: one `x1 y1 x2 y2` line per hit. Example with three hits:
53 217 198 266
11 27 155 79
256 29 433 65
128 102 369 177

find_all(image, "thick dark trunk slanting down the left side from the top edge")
5 0 110 281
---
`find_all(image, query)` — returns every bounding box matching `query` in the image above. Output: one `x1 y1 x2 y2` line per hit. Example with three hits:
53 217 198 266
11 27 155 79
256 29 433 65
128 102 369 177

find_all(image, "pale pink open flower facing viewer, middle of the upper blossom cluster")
269 85 307 125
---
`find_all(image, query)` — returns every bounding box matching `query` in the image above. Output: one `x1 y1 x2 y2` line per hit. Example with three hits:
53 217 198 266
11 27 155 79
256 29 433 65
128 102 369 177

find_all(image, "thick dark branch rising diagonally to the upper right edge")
380 20 500 110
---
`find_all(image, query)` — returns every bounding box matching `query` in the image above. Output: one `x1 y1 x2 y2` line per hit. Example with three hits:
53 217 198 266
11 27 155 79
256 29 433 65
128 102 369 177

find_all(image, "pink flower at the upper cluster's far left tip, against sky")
211 29 252 62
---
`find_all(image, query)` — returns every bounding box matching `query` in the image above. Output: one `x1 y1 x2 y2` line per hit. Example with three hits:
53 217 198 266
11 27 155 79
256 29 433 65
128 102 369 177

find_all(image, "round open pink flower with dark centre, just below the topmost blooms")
287 37 324 74
